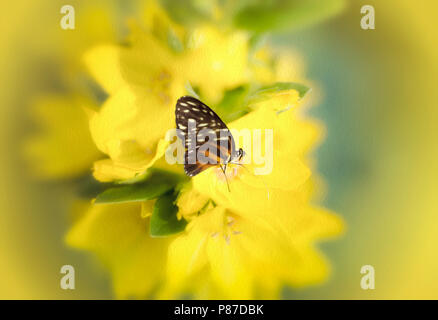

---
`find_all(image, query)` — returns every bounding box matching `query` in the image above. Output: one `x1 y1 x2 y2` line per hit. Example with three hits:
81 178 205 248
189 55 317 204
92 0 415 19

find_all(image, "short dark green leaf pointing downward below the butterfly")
149 192 187 237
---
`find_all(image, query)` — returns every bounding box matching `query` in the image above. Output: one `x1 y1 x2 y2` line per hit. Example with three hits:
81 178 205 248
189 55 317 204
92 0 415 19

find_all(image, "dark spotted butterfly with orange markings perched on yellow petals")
175 96 244 188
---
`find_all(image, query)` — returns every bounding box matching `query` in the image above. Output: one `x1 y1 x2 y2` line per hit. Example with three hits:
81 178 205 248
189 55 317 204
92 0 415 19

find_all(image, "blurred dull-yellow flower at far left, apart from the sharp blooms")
24 95 100 179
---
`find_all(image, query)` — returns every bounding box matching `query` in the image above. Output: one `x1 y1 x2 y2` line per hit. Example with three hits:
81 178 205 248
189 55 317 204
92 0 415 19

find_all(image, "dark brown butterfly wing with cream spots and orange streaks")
175 96 235 177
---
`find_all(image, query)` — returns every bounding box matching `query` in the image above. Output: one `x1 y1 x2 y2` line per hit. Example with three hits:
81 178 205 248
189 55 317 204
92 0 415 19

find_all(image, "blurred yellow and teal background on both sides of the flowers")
0 0 438 299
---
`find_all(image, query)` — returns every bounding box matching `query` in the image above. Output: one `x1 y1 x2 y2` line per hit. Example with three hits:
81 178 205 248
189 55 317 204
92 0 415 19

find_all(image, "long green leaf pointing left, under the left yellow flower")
95 169 182 204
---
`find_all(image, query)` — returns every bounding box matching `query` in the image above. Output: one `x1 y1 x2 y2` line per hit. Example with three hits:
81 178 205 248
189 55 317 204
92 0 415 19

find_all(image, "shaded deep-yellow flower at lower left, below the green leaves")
66 201 170 298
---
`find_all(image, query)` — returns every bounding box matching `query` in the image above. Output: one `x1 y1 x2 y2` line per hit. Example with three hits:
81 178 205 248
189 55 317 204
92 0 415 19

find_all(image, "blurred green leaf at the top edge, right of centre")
233 0 345 32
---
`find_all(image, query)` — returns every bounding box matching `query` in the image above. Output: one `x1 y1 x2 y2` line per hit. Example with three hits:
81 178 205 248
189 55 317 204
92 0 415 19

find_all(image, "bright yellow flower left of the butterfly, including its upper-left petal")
86 35 184 181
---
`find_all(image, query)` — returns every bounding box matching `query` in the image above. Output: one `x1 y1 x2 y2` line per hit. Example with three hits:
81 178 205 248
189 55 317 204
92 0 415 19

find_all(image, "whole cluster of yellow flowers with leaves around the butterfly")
25 2 342 299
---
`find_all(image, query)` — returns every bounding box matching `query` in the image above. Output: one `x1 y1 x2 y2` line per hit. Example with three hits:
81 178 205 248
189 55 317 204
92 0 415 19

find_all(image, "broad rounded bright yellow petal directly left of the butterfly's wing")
90 87 174 181
